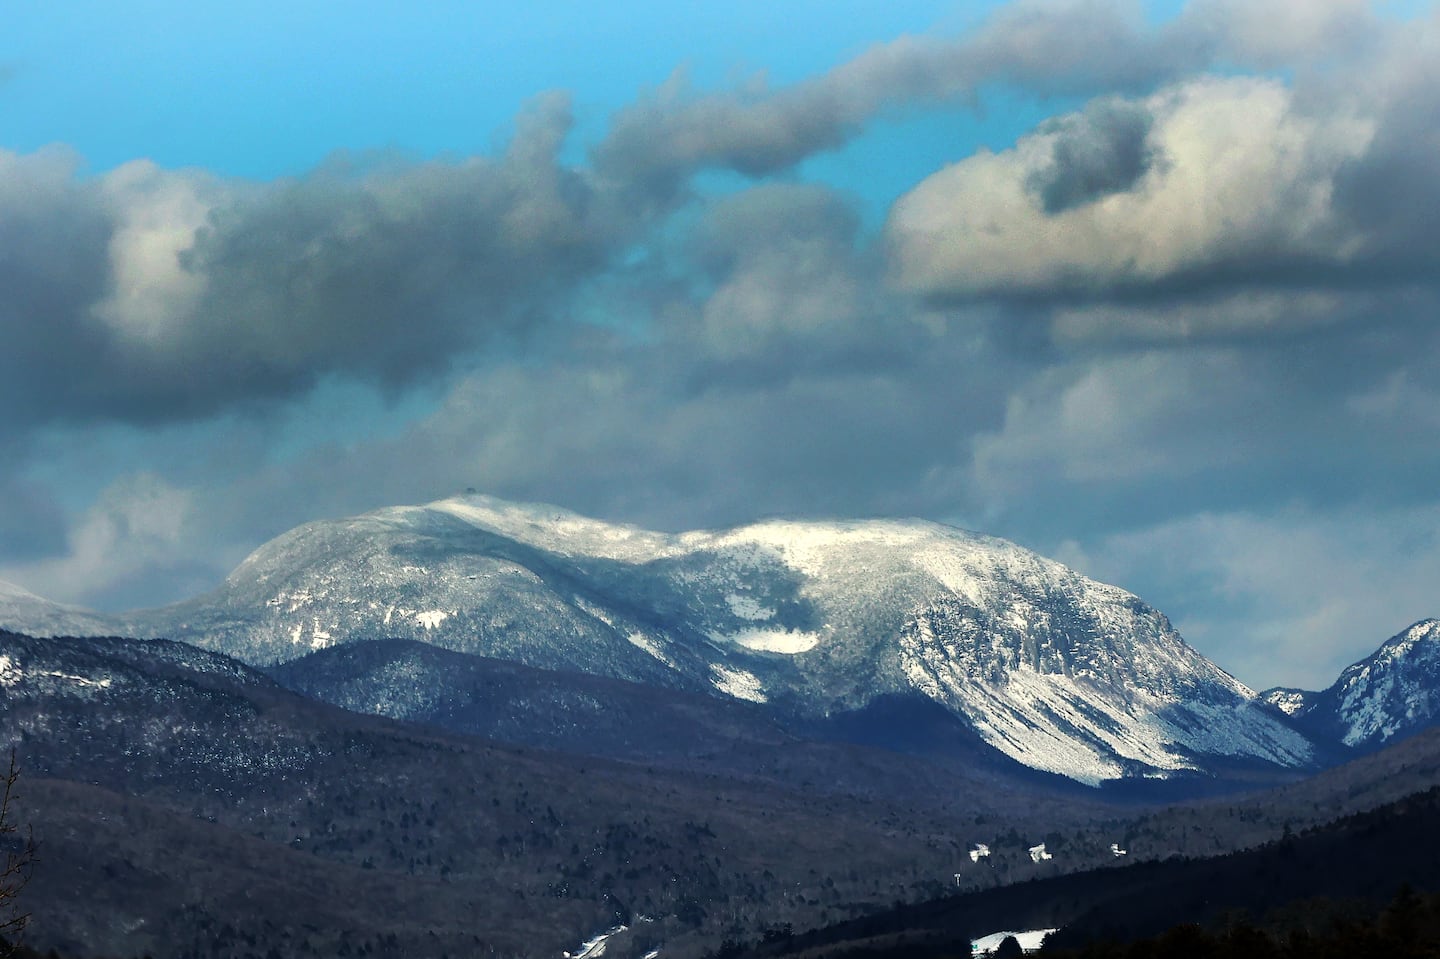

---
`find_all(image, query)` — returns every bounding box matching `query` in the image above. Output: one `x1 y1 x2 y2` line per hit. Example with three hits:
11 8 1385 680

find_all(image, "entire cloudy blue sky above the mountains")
0 0 1440 685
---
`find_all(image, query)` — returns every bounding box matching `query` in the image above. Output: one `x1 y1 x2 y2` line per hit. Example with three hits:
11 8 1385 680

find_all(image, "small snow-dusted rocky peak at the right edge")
1264 619 1440 750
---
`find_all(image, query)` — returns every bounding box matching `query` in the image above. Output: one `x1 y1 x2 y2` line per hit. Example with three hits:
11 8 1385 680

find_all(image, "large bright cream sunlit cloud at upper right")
887 1 1440 316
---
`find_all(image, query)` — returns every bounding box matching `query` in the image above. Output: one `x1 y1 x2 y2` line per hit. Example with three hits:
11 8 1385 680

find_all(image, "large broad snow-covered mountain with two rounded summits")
109 495 1315 783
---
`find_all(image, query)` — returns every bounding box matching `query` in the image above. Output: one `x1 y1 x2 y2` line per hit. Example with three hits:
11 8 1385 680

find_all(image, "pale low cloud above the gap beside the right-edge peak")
1058 504 1440 690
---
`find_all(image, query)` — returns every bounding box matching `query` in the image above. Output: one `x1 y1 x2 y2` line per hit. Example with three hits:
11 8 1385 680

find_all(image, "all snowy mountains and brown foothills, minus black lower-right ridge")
0 495 1440 958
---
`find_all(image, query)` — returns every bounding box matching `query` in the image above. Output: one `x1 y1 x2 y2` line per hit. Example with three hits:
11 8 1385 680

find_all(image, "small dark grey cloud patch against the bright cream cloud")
1028 99 1156 216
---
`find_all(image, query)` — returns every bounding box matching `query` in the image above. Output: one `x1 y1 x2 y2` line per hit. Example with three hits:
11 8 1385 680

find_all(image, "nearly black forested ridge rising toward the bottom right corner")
721 788 1440 959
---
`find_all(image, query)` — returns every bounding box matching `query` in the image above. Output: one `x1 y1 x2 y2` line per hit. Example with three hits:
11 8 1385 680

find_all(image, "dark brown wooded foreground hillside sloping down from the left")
0 634 1103 956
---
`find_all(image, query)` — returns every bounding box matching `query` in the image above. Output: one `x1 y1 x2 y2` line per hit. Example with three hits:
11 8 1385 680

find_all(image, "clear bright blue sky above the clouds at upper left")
8 0 1002 179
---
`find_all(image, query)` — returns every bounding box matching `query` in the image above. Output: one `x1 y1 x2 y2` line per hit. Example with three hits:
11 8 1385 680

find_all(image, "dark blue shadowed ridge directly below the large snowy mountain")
268 639 1076 805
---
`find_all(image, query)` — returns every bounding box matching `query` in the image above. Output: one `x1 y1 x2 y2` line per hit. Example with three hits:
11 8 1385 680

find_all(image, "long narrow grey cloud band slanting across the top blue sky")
593 0 1381 197
